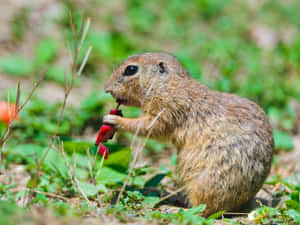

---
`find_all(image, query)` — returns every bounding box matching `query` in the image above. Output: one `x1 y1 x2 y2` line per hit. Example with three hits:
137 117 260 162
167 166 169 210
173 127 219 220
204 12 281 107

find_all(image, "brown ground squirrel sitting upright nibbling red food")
104 53 274 216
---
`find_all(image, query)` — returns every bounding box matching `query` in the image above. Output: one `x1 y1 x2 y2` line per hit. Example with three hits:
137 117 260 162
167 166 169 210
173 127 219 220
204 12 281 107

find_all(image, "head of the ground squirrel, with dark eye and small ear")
105 52 189 107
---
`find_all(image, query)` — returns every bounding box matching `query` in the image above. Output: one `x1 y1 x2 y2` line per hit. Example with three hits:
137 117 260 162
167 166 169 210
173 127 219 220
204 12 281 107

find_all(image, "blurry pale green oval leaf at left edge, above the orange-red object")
0 55 34 76
